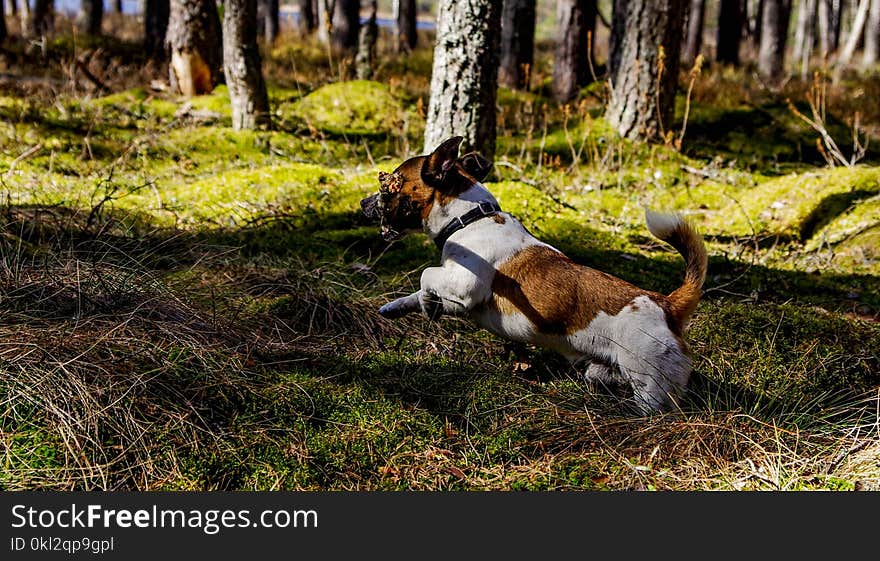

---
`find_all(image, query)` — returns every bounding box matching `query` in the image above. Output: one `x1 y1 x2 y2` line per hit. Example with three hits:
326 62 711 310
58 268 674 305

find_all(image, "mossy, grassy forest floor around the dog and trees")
0 28 880 490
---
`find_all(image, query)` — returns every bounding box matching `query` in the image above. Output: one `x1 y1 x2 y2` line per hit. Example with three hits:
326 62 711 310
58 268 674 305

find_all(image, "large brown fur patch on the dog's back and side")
492 246 677 334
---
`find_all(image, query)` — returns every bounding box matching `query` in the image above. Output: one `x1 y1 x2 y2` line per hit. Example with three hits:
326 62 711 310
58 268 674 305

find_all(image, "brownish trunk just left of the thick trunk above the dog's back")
553 0 596 102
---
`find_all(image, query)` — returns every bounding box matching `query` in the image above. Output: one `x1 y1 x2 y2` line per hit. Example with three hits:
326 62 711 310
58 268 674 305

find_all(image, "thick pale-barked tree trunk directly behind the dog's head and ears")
425 0 501 160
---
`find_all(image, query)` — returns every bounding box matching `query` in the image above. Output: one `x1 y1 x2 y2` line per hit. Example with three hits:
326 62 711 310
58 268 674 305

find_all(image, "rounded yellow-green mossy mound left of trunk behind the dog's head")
282 80 404 136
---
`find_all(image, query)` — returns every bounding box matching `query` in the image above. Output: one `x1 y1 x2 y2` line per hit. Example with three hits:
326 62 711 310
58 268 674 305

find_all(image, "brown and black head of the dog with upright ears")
361 136 492 241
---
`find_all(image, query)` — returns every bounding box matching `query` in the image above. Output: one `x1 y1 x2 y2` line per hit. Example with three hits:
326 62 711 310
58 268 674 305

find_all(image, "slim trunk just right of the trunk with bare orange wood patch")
223 0 270 130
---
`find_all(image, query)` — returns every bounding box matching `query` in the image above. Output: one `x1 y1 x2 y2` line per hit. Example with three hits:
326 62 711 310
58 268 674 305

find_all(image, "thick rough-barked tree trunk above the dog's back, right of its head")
606 0 684 140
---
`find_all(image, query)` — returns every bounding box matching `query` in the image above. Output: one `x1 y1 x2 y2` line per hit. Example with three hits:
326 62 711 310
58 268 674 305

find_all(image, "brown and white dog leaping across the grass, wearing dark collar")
361 137 706 413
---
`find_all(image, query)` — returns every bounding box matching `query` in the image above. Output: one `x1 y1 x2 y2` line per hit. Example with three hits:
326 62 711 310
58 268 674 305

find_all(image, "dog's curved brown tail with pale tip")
645 210 707 329
